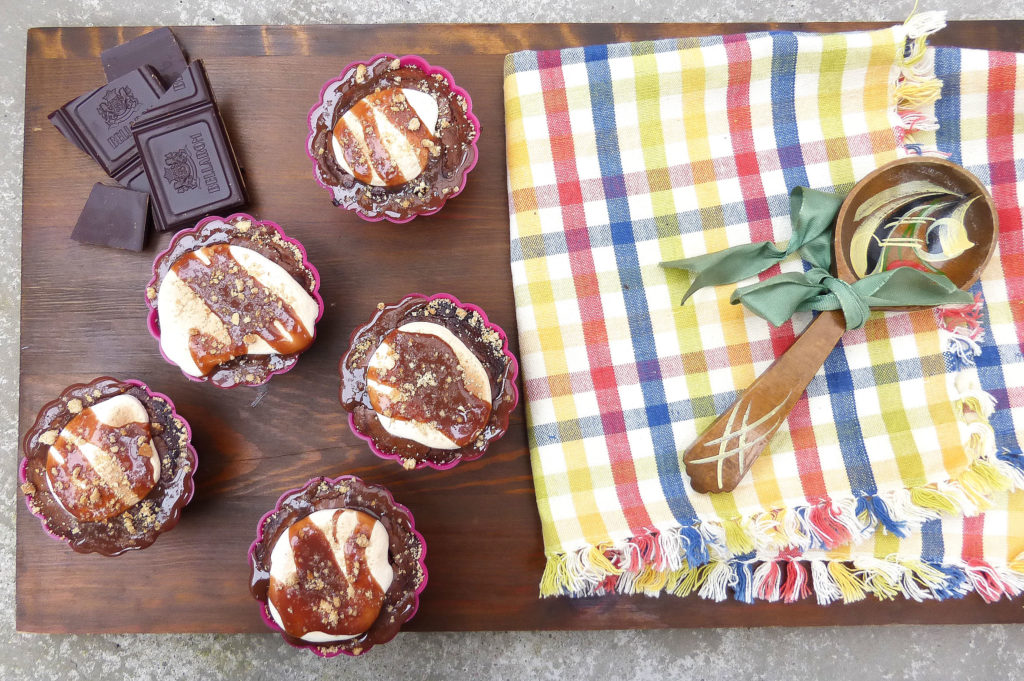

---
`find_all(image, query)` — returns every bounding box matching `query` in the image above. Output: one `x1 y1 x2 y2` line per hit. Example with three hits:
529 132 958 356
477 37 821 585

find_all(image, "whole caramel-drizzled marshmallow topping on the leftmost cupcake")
46 394 160 522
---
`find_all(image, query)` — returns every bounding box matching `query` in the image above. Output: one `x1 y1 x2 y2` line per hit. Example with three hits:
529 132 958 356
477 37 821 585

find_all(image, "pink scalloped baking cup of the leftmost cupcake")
17 376 199 557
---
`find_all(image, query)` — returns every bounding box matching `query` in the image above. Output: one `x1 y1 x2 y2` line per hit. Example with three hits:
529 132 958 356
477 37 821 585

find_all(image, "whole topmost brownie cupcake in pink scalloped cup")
307 54 480 222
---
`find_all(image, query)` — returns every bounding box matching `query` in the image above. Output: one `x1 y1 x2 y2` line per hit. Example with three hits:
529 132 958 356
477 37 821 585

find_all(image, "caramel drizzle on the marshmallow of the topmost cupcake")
334 87 434 186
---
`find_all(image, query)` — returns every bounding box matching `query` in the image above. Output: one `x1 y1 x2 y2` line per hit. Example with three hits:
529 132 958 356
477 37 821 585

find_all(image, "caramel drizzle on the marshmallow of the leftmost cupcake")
46 409 156 522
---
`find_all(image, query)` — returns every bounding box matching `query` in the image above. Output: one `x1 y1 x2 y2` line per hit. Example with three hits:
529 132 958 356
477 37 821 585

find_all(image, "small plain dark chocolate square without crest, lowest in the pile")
71 182 150 251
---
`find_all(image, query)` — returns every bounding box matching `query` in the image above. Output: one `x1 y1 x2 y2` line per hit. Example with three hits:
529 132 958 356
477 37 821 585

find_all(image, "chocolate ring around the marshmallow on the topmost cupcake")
309 56 478 220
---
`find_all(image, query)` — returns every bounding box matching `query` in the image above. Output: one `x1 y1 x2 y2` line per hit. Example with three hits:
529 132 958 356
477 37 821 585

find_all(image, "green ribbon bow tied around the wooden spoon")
662 186 974 329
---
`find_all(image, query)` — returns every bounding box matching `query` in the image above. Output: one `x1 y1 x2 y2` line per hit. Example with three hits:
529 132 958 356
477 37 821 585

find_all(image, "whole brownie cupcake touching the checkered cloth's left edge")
339 294 519 469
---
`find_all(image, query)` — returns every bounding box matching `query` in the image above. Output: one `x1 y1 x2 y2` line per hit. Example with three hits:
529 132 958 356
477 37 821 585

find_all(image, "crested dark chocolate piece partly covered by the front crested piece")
49 67 164 176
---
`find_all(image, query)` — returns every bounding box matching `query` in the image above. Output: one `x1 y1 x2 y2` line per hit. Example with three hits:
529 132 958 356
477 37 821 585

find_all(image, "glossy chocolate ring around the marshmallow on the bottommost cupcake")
249 477 427 655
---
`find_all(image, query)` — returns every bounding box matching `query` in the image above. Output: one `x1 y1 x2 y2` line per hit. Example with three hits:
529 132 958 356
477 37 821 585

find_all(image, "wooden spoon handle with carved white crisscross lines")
683 310 846 494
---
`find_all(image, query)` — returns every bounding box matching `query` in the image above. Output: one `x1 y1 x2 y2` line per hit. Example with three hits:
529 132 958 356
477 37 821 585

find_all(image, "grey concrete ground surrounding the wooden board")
0 0 1024 681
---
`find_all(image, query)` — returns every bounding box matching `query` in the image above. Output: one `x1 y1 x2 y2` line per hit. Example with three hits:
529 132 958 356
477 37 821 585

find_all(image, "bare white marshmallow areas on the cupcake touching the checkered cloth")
367 322 490 450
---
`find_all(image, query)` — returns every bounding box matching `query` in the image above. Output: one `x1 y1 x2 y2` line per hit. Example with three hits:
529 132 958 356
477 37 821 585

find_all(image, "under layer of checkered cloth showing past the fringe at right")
806 47 1024 600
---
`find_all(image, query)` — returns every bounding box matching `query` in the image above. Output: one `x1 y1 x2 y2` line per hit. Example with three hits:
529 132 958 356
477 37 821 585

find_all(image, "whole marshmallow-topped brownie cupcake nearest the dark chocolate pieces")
145 213 324 388
